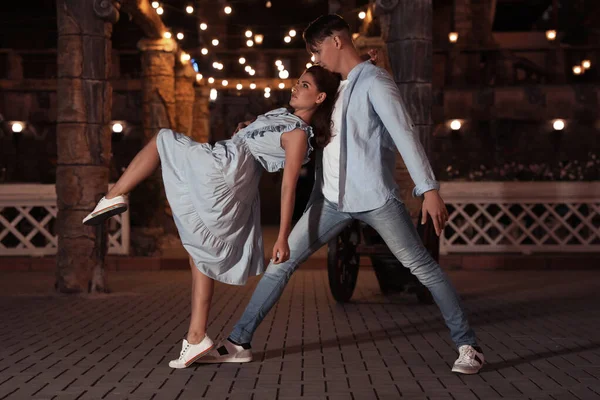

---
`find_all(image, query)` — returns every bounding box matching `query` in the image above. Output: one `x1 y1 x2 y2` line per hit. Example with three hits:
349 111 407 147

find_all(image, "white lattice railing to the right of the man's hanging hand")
440 182 600 254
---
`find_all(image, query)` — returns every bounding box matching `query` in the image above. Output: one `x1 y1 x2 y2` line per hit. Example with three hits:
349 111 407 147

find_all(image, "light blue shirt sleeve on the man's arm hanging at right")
369 70 440 197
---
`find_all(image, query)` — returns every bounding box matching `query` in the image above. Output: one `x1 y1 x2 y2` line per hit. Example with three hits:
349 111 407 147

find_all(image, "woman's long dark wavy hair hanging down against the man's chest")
306 65 341 148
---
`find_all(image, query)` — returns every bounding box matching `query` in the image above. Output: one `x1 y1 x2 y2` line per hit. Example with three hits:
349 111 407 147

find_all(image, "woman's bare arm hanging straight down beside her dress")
272 129 308 264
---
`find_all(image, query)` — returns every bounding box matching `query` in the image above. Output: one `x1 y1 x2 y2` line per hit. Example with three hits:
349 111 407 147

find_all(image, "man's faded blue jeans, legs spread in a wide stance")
229 198 477 347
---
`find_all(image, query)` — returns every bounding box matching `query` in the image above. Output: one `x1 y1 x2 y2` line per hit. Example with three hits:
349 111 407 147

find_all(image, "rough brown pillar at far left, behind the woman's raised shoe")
56 0 119 293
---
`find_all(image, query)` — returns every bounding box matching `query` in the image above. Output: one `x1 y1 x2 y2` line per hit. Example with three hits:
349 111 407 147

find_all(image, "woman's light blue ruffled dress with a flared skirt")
157 108 314 285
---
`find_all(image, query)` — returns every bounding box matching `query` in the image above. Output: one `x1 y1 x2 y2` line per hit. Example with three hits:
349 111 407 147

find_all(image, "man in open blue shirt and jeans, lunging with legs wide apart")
197 15 484 374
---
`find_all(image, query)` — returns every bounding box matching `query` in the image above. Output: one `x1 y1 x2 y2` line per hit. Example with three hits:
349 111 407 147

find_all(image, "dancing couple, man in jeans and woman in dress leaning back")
83 15 484 374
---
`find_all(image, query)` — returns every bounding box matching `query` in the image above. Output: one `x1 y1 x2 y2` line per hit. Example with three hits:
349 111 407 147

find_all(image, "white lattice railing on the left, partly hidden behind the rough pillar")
0 184 130 256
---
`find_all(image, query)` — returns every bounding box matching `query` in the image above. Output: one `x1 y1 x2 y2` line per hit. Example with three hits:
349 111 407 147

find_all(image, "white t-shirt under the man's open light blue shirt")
323 79 348 203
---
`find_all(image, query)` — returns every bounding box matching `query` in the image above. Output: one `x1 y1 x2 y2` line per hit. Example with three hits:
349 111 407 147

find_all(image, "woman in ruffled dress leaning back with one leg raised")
83 66 340 368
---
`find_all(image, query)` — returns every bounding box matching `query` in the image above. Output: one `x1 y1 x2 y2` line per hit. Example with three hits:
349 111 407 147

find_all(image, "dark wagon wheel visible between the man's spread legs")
327 223 360 302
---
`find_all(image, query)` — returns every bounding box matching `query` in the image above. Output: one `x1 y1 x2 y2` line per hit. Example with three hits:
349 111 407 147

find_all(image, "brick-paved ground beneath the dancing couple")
0 270 600 400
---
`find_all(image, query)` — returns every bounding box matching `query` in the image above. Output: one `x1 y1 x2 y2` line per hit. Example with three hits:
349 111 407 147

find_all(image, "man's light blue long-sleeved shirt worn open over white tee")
309 61 440 212
